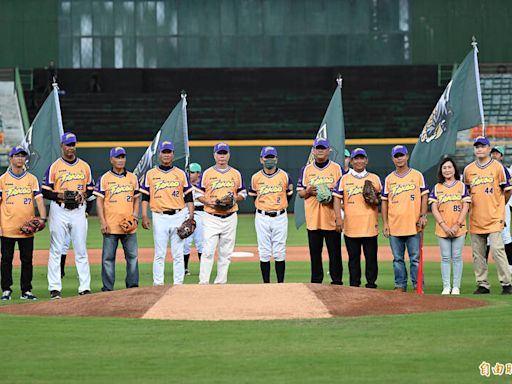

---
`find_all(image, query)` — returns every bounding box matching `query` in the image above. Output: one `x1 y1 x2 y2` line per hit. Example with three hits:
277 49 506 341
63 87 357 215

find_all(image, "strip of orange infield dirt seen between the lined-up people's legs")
24 246 480 266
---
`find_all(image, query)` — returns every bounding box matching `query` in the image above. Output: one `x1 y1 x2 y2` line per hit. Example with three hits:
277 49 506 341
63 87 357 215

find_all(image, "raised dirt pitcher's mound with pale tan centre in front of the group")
0 284 486 320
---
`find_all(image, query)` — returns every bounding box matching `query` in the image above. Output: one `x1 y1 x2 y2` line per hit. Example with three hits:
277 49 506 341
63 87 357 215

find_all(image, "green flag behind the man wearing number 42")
133 92 190 179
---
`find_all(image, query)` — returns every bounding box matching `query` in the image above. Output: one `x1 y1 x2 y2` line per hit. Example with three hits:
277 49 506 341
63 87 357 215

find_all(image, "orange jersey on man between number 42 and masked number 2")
199 166 246 215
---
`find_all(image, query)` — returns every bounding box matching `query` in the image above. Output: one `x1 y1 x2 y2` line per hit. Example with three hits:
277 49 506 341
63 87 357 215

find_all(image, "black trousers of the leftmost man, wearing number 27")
1 236 34 292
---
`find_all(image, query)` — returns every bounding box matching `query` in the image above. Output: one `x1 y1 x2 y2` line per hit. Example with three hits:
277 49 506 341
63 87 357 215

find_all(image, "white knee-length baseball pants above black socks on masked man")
254 212 288 262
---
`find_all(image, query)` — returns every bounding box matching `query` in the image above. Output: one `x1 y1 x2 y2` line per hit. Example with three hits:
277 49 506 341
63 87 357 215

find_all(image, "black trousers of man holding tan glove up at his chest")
308 229 343 285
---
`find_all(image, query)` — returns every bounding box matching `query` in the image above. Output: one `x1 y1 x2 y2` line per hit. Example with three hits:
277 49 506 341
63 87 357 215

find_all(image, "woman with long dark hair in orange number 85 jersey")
429 157 471 295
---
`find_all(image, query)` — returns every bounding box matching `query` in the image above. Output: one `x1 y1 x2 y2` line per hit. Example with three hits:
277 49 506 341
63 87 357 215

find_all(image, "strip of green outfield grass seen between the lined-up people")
34 214 470 249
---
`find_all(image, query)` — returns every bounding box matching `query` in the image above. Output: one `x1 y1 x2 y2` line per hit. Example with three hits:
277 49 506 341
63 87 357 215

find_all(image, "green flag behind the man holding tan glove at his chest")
294 78 345 229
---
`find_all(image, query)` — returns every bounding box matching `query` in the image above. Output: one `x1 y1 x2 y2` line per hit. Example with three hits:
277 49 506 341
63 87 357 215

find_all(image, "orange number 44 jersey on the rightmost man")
464 159 512 234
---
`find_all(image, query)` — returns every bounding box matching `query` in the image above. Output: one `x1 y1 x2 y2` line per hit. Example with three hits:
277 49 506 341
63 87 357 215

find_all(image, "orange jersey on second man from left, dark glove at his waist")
43 157 94 193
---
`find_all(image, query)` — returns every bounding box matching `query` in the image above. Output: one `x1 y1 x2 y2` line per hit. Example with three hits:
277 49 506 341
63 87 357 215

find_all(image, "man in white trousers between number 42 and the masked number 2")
199 143 247 284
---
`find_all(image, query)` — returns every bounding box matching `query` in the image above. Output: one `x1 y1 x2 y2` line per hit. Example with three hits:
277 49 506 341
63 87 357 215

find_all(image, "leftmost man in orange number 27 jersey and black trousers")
0 146 46 300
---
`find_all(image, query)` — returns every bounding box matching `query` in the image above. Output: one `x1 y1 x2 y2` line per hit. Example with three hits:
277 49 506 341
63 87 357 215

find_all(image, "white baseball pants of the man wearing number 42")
152 208 188 285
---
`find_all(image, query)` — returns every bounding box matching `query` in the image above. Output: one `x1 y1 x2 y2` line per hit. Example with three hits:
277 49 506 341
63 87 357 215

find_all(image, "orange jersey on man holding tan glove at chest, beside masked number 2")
297 160 343 231
